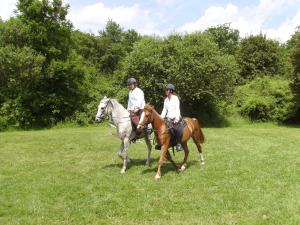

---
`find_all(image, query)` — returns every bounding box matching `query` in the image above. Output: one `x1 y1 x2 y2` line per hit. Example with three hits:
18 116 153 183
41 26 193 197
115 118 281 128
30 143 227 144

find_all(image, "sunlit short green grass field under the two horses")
0 126 300 225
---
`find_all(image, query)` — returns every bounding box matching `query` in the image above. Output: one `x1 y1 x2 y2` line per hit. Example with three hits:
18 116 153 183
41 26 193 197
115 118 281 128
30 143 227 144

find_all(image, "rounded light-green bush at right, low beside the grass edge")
234 77 295 122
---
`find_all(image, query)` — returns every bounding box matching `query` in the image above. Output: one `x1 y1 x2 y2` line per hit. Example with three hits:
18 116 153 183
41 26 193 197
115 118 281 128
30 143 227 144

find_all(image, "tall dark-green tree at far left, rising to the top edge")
0 0 87 126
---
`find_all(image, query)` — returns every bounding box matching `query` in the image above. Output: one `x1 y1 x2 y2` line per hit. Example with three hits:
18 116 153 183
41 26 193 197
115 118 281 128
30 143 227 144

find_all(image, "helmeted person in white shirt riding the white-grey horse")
127 77 145 138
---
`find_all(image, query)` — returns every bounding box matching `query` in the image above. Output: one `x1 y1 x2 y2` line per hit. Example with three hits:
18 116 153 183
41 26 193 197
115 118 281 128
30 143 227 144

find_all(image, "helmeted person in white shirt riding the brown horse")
157 84 182 151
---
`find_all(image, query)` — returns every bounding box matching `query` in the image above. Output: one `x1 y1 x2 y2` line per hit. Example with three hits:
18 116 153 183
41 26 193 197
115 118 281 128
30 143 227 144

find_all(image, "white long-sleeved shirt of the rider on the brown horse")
161 95 181 120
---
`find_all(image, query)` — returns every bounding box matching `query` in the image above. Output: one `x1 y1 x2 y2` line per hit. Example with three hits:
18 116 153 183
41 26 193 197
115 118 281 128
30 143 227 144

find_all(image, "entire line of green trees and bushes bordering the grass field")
0 0 300 130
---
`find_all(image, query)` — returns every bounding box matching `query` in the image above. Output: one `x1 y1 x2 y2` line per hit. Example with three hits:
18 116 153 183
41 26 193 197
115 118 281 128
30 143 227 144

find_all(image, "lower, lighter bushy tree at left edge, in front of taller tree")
0 45 45 130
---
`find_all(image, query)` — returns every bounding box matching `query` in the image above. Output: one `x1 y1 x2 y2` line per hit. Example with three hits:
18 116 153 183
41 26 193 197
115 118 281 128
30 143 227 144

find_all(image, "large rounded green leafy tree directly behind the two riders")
123 33 238 123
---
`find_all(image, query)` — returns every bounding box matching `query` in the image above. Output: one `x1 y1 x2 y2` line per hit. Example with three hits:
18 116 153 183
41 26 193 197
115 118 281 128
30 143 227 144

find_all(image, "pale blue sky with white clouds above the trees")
0 0 300 42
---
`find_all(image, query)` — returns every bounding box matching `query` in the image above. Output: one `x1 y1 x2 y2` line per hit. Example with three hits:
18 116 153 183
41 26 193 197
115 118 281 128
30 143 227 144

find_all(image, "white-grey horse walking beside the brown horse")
95 96 152 173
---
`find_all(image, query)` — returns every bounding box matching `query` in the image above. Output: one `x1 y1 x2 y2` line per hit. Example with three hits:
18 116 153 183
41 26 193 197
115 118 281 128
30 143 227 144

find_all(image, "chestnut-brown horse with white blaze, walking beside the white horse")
138 104 204 180
